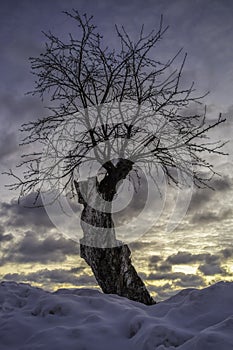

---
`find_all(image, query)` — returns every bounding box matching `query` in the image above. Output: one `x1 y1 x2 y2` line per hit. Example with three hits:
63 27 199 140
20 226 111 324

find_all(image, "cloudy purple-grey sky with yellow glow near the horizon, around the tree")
0 0 233 299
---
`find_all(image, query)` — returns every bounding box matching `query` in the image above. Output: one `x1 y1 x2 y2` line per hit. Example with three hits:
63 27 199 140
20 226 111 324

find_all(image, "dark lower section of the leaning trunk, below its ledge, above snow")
80 243 156 305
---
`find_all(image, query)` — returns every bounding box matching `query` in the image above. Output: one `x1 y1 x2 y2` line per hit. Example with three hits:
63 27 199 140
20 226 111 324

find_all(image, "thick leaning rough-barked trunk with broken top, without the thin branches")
75 159 155 305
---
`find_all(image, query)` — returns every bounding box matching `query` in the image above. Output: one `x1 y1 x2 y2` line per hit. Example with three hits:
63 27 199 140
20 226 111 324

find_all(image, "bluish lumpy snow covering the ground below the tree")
0 282 233 350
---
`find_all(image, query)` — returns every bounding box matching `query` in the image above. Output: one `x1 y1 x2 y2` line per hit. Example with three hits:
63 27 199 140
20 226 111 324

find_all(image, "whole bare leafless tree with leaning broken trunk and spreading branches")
6 10 227 305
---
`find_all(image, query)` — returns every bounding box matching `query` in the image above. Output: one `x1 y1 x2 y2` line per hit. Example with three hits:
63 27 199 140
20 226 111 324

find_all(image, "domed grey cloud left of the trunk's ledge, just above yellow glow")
3 231 79 264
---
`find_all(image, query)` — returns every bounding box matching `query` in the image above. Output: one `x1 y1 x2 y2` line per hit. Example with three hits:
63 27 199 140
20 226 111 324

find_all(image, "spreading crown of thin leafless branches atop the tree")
5 10 228 209
